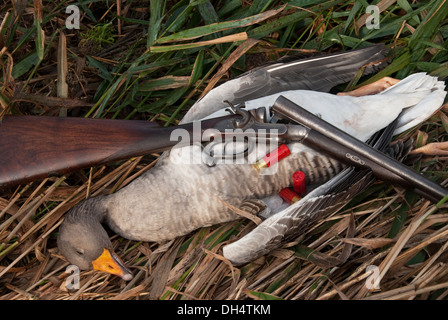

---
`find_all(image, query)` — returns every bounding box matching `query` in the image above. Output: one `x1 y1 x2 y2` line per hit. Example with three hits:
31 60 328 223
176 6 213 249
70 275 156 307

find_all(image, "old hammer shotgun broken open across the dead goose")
0 96 448 202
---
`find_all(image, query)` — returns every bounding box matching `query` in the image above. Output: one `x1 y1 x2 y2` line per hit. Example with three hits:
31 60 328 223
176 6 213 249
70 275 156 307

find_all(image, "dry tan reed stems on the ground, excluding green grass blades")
0 0 448 300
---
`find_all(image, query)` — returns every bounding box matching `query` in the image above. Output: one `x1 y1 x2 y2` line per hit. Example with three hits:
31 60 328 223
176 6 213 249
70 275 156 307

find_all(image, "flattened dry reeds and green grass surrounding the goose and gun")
0 0 448 300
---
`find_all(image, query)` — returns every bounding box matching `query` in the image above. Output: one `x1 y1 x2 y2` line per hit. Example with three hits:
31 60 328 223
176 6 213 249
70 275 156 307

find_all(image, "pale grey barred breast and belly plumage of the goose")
101 149 343 242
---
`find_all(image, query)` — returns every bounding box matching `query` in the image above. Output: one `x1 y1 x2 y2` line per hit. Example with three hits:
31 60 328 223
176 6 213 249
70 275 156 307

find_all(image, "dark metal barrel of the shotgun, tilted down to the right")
272 96 448 202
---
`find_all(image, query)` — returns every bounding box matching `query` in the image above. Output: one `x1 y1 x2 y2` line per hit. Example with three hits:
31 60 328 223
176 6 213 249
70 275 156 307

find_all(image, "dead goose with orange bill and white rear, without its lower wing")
58 46 445 280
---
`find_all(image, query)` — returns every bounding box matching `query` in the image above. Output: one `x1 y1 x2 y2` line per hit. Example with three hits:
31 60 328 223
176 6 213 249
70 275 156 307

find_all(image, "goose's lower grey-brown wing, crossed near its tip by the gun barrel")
223 121 412 265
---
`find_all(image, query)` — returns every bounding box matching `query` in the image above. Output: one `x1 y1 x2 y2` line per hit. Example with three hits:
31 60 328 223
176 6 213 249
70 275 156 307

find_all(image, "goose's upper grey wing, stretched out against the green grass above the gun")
181 44 389 123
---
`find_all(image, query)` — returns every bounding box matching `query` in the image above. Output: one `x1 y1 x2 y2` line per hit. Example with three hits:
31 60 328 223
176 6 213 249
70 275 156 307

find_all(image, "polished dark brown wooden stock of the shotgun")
0 116 231 187
